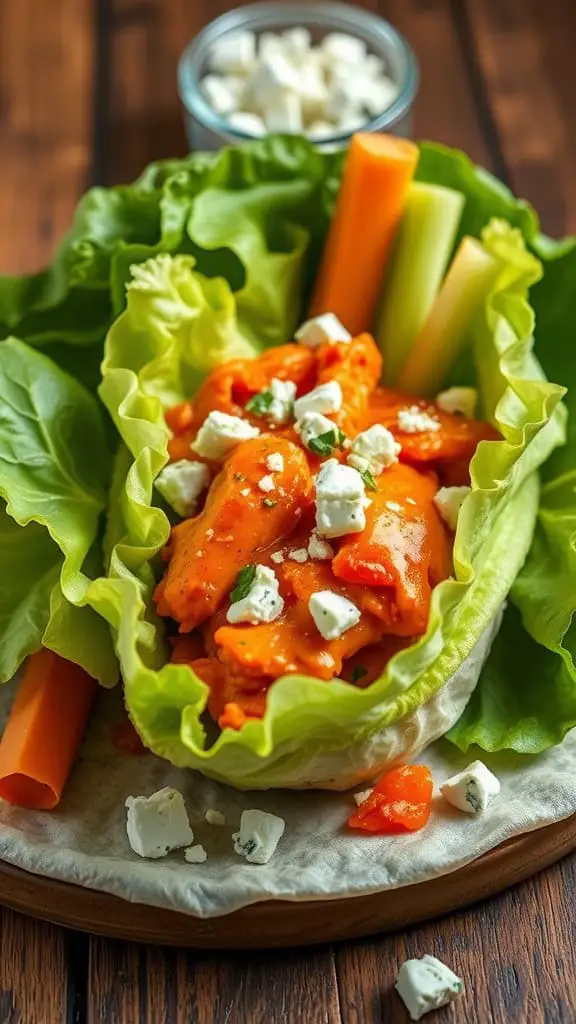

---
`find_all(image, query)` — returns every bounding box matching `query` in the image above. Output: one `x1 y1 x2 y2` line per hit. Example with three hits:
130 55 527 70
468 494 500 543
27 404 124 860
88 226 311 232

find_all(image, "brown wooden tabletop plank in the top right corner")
466 0 576 236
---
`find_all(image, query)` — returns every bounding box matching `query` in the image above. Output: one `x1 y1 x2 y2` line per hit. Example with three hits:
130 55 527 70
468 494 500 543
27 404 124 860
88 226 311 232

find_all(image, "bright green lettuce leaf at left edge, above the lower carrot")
0 338 118 683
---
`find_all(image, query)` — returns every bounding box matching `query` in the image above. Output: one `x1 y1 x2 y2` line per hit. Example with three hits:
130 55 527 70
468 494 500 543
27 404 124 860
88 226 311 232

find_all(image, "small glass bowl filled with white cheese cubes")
178 3 418 151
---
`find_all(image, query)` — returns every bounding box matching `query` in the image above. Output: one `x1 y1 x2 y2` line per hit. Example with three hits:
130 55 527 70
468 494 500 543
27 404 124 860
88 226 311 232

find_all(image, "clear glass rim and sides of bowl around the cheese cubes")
178 2 418 151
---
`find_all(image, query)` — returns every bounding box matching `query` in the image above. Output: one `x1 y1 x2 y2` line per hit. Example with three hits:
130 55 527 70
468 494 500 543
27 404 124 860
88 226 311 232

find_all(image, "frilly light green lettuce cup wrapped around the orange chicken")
94 147 565 787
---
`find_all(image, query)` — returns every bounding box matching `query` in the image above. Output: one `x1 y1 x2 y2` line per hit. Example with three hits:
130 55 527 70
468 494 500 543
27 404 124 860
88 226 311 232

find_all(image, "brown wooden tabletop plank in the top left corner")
0 0 94 273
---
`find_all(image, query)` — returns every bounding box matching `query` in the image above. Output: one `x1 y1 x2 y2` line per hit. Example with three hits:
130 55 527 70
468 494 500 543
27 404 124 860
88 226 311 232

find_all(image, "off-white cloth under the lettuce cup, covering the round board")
0 687 576 918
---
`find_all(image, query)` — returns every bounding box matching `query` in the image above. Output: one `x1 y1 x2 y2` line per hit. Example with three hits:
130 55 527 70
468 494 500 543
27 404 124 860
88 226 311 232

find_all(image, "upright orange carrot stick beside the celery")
311 133 418 335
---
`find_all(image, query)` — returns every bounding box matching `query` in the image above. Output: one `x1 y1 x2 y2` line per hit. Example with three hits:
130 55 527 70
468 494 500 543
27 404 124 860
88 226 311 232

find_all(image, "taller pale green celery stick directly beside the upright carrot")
376 182 464 384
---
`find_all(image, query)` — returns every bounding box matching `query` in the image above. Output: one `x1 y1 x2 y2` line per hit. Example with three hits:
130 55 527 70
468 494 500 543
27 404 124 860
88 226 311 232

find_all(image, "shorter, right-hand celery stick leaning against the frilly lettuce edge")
397 236 502 395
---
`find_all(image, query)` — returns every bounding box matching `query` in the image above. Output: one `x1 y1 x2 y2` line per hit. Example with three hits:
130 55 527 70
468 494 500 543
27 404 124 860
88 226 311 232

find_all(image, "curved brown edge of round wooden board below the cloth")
0 815 576 949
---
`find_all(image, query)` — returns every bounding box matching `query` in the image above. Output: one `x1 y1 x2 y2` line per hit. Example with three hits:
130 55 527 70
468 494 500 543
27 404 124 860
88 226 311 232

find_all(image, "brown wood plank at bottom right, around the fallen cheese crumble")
336 858 576 1024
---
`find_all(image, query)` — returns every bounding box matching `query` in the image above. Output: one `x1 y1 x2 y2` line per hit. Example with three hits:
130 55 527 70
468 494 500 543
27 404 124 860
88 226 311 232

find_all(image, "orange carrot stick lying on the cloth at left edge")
0 648 97 810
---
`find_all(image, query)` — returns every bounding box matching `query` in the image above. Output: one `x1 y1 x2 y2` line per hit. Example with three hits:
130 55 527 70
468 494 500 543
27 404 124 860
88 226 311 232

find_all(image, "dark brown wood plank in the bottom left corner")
0 907 68 1024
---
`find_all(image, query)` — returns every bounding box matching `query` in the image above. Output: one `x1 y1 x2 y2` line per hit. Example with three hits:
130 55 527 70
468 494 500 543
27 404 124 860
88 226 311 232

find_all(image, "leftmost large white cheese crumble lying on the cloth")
126 788 194 860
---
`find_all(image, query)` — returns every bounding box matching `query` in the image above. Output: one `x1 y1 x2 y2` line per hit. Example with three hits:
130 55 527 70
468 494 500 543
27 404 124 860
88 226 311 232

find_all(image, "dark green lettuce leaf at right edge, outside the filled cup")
449 237 576 754
